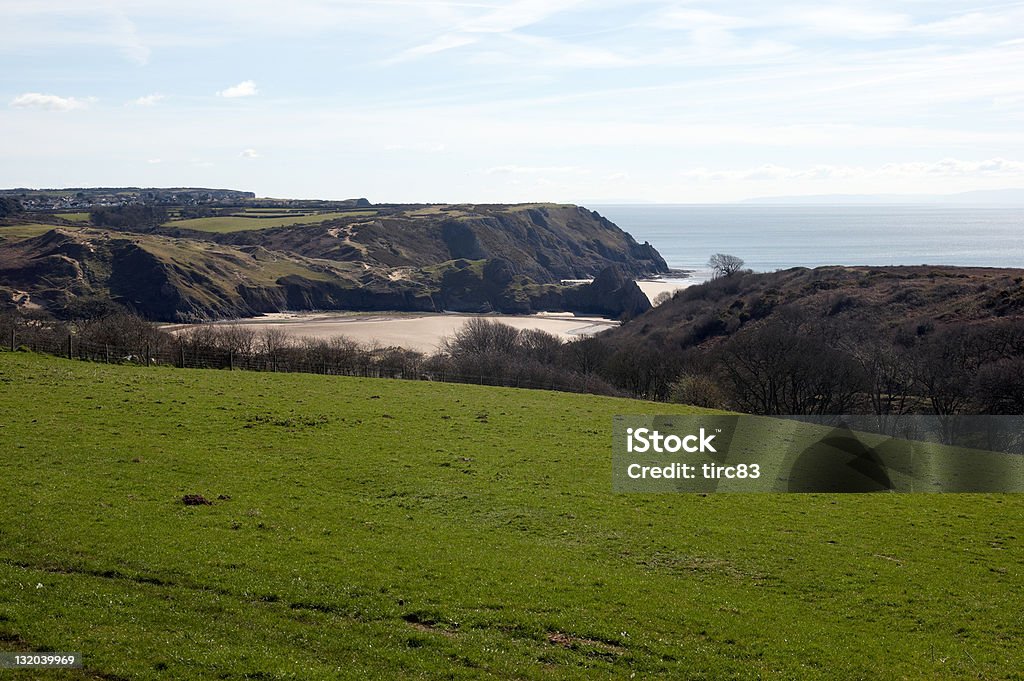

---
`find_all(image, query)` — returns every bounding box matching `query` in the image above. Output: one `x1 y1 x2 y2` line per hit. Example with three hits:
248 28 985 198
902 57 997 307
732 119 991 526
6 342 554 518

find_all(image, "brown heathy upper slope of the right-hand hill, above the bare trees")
610 265 1024 350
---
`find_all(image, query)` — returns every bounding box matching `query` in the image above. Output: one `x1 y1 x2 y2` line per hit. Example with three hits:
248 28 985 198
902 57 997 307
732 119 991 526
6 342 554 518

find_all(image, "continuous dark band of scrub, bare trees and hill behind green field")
0 258 1024 421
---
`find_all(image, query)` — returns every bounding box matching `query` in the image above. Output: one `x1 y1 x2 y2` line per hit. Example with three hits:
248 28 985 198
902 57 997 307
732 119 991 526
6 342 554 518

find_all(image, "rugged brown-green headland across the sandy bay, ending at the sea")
0 201 667 322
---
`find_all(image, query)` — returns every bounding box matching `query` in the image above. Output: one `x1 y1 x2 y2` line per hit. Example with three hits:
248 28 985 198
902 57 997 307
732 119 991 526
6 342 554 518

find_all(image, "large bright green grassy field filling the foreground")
0 352 1024 679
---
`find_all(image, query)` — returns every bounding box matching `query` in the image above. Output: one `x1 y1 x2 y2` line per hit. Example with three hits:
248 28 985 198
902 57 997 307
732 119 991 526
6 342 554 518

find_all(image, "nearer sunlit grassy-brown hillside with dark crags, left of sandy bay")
0 229 387 322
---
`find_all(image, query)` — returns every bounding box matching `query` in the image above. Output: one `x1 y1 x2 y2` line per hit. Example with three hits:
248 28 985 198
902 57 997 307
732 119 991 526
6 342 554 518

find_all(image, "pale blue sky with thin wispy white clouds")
0 0 1024 204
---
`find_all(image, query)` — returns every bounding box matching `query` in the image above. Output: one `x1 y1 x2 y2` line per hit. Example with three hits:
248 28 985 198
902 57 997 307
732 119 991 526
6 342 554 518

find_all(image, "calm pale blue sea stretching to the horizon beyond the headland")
588 204 1024 279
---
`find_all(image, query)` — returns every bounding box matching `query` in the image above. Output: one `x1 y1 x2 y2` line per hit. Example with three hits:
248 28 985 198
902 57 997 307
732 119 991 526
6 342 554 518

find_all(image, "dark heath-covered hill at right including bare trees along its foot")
602 266 1024 409
